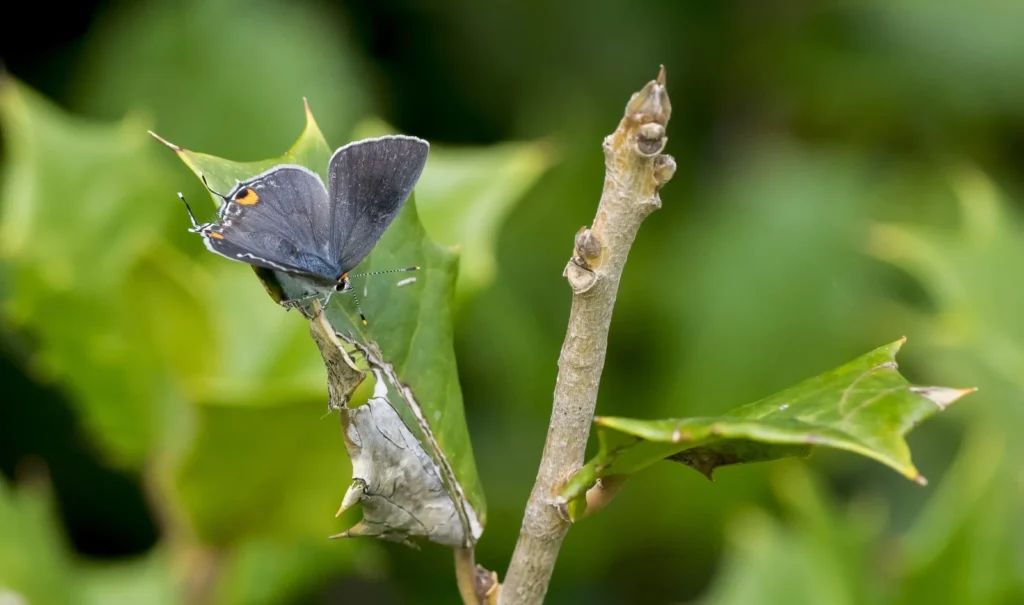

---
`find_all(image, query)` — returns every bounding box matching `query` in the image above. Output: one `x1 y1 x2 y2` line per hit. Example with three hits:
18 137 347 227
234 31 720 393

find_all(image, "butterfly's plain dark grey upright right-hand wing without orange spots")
328 135 430 273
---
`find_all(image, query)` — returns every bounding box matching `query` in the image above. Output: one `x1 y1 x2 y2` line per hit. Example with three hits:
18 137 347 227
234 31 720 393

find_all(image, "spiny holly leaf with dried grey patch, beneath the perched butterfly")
152 105 484 546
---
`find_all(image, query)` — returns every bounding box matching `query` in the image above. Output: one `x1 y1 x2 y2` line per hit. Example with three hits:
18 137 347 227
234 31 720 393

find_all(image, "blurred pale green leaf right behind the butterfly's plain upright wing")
354 119 554 298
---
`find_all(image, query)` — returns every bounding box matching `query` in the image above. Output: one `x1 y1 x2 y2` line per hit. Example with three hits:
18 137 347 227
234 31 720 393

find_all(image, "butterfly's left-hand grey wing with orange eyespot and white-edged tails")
202 165 341 279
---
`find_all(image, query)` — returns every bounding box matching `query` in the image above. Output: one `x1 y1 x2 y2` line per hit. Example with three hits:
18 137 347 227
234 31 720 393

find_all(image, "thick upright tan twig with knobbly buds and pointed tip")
499 68 676 605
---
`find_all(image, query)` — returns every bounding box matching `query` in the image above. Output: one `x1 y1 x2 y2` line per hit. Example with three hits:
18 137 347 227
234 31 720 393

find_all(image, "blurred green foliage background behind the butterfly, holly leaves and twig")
0 0 1024 605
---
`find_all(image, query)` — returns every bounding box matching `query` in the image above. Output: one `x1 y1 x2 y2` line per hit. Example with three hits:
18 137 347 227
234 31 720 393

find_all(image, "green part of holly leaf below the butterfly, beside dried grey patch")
313 199 484 535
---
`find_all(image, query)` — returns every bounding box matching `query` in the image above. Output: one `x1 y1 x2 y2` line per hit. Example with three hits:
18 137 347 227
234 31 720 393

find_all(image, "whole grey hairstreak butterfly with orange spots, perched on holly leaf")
178 135 430 323
